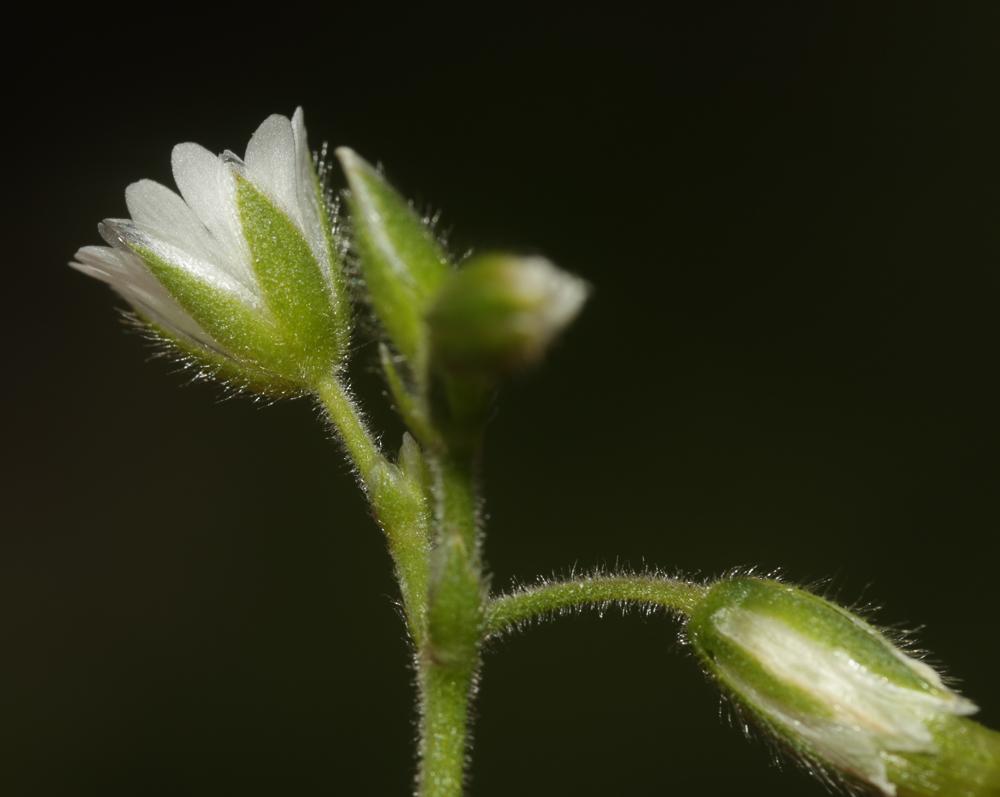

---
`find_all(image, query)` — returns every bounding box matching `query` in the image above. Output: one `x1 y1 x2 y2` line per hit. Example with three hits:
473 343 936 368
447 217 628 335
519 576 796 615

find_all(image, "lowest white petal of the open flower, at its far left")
70 246 219 346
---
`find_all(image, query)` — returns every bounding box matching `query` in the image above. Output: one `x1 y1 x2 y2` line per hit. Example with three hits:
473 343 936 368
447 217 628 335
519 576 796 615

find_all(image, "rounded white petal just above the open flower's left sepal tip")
125 180 224 262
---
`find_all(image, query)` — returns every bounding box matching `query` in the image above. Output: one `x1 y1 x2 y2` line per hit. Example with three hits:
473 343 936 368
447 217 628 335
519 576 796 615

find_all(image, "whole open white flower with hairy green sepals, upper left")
71 108 350 393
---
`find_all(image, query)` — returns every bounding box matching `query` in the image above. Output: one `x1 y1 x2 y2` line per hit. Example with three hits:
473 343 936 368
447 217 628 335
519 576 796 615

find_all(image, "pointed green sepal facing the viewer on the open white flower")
236 177 350 381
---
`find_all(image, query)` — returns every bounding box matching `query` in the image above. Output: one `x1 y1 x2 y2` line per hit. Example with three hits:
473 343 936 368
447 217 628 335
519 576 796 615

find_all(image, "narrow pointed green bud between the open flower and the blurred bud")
337 147 451 372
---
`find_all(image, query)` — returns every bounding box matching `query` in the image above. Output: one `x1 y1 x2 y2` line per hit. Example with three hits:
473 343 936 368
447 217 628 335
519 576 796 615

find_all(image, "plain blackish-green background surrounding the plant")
7 2 1000 797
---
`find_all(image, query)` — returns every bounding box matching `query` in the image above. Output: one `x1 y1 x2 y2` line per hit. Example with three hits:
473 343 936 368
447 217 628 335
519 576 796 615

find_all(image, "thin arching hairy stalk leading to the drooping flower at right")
485 574 706 637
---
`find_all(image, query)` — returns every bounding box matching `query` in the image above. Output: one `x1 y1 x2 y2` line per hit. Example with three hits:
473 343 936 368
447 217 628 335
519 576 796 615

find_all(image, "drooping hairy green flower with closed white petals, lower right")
688 578 1000 797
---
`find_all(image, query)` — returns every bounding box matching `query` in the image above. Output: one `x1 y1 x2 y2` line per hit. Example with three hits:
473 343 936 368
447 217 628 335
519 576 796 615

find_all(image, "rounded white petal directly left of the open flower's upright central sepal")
171 144 257 291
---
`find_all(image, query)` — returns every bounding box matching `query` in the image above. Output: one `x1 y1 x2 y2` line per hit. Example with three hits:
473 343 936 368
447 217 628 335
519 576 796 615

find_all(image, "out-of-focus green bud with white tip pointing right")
427 254 587 376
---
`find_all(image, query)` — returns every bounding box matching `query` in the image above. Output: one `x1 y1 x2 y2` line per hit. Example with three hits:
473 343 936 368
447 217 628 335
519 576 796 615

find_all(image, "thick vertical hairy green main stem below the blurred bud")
417 454 484 797
